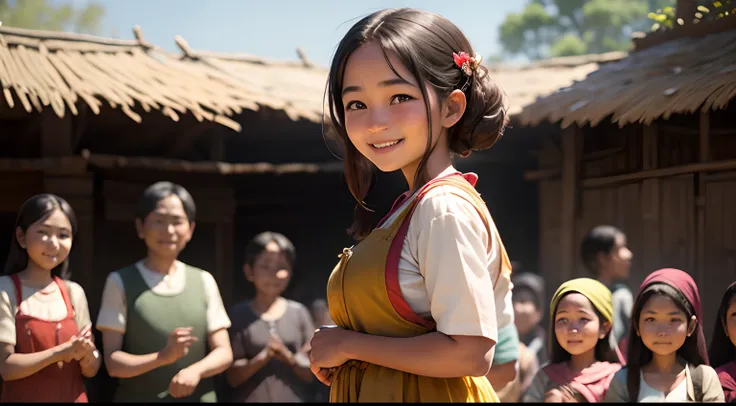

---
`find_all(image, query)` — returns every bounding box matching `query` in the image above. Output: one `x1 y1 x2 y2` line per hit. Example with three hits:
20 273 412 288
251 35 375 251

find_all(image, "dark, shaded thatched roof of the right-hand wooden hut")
518 18 736 127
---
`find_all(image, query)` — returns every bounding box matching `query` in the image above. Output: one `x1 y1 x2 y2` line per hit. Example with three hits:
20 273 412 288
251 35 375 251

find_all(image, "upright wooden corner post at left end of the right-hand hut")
560 126 582 280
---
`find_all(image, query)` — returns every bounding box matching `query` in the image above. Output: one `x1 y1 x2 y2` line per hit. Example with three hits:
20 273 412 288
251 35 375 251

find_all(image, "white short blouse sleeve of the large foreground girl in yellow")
409 188 498 341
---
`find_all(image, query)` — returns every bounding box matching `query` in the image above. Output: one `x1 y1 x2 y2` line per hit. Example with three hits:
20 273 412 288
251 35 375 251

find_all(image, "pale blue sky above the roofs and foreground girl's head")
67 0 526 66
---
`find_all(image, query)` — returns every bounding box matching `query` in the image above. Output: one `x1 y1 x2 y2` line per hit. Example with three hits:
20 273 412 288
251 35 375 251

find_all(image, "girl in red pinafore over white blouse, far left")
0 194 101 403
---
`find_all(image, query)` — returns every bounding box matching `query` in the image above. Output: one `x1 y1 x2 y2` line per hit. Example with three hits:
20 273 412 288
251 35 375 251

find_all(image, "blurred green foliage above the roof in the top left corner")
0 0 105 34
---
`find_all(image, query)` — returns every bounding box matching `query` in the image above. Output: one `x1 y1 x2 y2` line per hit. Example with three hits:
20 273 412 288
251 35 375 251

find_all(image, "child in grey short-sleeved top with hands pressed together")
227 231 314 403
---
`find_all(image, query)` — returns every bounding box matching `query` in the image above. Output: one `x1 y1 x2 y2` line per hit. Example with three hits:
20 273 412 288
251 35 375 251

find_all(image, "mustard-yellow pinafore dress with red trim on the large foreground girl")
327 173 511 402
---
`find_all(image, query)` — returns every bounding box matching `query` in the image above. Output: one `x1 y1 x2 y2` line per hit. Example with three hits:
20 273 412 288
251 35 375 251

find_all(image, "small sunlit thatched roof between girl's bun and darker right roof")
488 52 626 116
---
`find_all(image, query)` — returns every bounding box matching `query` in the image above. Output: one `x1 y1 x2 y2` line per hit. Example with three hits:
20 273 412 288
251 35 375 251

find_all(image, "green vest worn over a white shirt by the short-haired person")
115 265 217 402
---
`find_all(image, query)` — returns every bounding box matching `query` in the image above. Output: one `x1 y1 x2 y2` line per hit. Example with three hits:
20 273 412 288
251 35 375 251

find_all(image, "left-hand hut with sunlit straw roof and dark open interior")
0 27 352 400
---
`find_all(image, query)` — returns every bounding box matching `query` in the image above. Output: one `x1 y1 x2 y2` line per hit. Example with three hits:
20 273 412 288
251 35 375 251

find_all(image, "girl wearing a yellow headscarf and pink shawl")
523 278 622 403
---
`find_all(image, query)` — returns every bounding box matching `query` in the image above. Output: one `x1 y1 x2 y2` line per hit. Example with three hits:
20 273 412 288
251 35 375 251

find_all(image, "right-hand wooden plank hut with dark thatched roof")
518 15 736 332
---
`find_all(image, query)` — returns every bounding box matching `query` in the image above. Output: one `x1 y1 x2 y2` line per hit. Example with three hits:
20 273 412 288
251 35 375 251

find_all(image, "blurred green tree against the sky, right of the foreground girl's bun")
499 0 671 59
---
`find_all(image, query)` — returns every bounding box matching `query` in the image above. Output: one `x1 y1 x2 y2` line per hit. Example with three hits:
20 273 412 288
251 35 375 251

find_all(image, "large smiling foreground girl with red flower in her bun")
310 9 513 402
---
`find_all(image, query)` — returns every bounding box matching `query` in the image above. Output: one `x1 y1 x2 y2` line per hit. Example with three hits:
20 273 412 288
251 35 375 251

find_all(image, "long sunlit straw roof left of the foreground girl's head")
0 27 326 131
